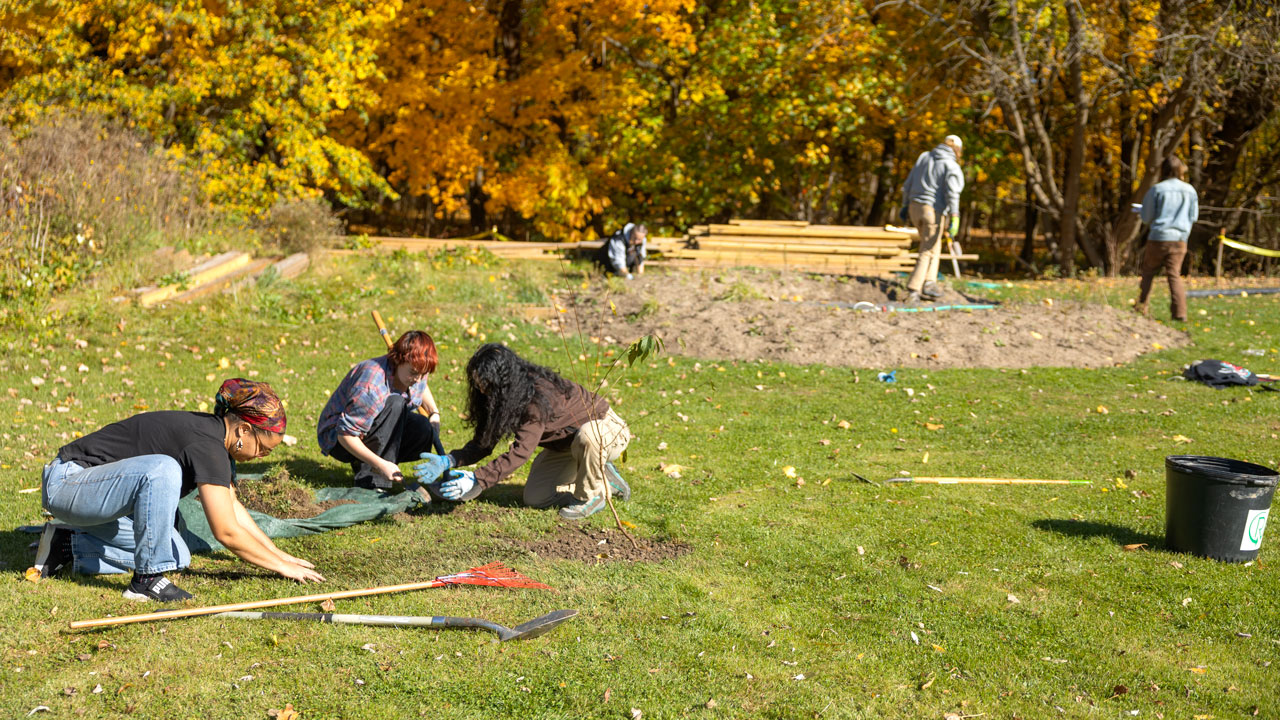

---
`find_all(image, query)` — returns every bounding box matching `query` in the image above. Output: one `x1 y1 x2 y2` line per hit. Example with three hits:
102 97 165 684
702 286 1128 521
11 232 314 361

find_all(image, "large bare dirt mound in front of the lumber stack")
559 269 1189 369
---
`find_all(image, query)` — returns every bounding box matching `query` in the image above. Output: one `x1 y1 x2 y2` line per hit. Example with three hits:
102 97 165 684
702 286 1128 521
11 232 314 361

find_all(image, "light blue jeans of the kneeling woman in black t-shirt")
41 455 191 575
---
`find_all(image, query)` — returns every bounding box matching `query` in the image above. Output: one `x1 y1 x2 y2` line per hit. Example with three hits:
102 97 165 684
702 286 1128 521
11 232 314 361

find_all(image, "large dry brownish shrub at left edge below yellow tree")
0 115 211 324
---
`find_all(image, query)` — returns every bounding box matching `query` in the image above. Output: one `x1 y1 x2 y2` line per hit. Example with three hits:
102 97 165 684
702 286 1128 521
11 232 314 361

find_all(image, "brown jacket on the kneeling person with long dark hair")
449 379 609 488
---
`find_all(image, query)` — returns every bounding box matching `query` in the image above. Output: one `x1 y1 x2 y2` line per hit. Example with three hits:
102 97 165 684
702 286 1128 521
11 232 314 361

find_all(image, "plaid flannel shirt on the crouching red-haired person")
316 355 426 455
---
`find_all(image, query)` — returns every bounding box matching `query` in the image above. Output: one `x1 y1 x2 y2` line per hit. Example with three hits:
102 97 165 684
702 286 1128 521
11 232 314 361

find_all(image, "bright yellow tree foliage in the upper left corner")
0 0 399 213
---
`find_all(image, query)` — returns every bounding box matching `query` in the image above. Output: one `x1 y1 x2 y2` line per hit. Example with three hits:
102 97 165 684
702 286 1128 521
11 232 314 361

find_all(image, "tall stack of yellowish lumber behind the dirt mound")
664 220 916 275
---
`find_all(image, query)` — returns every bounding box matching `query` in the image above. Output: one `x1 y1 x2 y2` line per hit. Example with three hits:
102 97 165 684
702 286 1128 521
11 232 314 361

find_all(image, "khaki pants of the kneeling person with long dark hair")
525 409 631 507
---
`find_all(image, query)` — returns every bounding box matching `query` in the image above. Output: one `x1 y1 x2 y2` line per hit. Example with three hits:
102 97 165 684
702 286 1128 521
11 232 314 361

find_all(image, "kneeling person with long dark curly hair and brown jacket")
415 343 631 520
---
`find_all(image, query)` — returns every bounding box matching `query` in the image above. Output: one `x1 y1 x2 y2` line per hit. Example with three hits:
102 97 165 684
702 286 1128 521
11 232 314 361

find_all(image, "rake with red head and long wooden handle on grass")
70 562 552 630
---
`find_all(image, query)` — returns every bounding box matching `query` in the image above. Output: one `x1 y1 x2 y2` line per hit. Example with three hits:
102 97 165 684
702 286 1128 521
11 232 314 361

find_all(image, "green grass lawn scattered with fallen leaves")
0 254 1280 719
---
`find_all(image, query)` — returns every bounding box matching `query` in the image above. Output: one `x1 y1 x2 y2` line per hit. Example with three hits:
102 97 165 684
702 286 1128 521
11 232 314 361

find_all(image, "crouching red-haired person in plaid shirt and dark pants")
316 331 440 489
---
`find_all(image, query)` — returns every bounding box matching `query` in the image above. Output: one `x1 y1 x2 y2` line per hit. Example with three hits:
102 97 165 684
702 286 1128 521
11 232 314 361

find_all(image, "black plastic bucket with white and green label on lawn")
1165 455 1280 562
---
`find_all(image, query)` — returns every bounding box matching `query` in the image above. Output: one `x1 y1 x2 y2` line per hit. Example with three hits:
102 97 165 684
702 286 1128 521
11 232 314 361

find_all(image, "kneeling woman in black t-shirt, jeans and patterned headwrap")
36 379 324 602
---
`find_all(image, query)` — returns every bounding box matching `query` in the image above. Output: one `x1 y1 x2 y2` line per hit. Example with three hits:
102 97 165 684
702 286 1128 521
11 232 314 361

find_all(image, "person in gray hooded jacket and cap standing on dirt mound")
900 135 964 302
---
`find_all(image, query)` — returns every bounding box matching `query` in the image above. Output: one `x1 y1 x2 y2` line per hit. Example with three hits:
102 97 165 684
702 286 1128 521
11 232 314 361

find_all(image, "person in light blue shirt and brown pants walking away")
1137 155 1199 320
